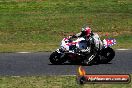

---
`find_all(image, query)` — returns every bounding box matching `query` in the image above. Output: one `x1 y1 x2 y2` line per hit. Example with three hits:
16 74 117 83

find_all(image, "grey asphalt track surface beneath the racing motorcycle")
0 50 132 76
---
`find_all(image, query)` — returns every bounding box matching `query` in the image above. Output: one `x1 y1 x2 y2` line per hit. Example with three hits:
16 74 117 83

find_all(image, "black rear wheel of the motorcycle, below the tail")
100 47 115 64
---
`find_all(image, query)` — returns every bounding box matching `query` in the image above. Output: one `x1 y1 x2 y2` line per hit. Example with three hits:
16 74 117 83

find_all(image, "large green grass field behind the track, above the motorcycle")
0 0 132 52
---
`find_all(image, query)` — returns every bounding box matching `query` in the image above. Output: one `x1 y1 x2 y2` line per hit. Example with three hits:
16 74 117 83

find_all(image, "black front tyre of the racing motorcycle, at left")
49 51 65 64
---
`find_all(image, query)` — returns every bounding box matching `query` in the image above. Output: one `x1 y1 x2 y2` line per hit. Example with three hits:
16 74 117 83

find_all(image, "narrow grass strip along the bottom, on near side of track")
0 76 132 88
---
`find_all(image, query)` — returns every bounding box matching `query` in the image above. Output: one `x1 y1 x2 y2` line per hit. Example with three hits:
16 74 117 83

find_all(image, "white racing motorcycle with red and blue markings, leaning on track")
49 33 116 65
